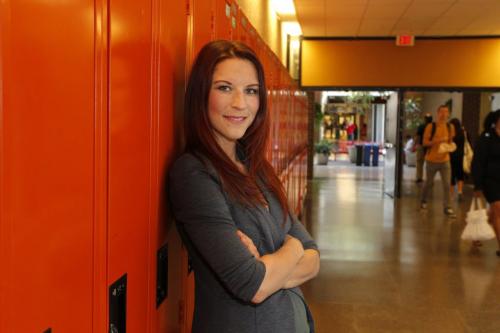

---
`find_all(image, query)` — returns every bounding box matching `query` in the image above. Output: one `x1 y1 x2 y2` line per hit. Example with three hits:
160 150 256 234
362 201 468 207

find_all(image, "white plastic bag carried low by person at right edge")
461 198 495 241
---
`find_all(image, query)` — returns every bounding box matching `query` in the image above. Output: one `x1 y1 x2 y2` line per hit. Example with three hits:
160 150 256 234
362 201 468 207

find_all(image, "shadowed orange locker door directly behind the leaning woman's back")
154 0 188 333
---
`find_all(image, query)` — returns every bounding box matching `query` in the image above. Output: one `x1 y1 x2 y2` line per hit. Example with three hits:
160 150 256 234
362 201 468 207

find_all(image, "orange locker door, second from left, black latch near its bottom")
108 0 151 332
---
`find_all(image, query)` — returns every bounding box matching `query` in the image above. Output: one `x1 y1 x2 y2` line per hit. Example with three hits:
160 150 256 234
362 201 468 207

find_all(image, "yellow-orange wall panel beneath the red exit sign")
301 38 500 87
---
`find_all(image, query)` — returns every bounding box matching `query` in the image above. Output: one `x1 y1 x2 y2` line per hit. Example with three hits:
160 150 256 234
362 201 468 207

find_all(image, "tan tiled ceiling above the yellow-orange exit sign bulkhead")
294 0 500 37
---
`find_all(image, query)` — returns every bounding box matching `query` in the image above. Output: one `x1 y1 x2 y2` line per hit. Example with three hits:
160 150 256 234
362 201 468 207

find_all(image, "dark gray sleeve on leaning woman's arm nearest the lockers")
169 155 266 302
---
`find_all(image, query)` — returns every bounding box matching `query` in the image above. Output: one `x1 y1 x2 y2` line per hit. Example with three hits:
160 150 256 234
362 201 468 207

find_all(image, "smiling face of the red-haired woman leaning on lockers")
208 58 259 147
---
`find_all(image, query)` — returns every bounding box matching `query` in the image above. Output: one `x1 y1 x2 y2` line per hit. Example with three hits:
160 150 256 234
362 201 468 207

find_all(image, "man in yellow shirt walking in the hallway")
420 105 455 217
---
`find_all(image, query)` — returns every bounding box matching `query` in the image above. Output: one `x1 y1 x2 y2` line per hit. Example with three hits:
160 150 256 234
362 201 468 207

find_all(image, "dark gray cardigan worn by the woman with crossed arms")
169 153 317 333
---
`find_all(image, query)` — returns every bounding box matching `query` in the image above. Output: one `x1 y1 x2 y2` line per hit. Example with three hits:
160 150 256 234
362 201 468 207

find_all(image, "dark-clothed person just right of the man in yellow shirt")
450 118 465 200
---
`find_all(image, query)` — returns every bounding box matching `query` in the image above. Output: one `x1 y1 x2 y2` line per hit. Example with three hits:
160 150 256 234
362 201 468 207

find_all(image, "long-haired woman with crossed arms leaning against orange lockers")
169 41 319 333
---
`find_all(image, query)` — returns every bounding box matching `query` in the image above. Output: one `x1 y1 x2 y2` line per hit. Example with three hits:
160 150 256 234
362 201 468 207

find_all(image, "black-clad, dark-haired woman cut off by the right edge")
472 109 500 257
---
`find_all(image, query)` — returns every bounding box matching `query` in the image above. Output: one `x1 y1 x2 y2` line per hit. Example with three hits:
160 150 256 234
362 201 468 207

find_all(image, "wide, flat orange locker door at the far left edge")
0 0 96 333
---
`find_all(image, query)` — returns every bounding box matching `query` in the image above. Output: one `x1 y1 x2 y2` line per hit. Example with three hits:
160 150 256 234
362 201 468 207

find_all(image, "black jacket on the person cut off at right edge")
472 130 500 191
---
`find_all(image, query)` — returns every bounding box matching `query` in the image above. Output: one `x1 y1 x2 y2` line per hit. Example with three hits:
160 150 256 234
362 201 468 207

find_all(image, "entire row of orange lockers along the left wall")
0 0 307 333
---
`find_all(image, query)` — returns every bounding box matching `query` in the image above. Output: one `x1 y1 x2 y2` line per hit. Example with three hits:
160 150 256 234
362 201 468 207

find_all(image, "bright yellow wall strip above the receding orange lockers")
237 0 284 60
